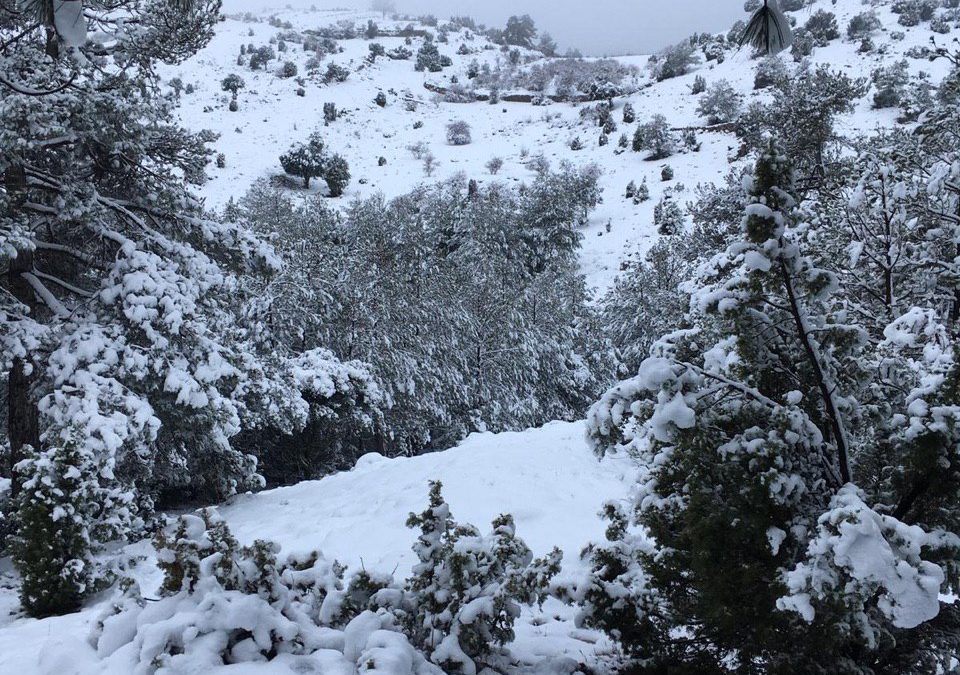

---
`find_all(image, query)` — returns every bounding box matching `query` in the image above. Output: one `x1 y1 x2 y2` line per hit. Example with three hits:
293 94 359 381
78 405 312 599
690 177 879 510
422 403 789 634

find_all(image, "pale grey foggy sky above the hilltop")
224 0 744 56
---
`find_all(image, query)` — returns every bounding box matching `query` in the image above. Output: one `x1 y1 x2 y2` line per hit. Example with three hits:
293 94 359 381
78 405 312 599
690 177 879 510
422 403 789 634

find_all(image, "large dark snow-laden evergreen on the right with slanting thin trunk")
561 137 960 673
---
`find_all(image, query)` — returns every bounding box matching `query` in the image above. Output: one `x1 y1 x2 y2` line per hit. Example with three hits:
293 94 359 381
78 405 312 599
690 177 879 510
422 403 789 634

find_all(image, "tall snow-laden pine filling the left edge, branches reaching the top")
0 0 368 611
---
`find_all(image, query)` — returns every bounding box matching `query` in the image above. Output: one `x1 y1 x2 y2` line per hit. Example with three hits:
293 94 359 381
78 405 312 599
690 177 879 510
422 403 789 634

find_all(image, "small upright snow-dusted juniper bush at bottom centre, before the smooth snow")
404 481 562 675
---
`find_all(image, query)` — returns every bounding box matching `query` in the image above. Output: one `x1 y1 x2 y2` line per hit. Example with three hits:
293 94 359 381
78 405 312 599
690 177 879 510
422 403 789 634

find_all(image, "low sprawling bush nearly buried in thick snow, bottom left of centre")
91 511 441 675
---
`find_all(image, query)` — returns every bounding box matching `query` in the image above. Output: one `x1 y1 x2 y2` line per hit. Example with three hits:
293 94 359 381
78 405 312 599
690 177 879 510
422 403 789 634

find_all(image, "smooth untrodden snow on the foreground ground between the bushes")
0 422 633 675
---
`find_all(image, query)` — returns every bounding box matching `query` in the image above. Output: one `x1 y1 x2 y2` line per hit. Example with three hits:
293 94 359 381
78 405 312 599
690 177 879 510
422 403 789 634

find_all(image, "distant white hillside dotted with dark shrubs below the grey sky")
169 0 948 289
